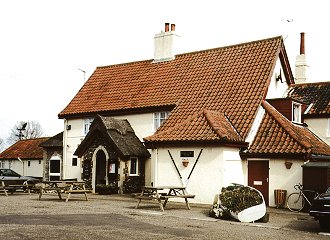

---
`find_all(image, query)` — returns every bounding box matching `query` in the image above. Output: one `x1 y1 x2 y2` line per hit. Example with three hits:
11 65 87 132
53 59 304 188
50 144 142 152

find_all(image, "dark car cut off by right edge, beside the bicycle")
309 188 330 231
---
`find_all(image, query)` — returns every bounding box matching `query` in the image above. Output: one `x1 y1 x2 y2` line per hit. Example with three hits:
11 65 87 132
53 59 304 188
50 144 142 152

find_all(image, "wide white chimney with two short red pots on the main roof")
154 23 178 63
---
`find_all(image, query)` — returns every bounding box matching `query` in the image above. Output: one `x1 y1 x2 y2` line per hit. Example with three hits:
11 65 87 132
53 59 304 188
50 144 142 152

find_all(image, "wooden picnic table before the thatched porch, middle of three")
36 180 91 202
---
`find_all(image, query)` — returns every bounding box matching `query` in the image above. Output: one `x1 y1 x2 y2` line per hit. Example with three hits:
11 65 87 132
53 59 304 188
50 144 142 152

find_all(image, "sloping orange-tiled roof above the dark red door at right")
242 101 330 159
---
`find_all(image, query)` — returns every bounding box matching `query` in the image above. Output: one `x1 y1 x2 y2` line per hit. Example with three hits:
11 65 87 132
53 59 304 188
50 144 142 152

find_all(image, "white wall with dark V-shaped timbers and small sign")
152 147 244 204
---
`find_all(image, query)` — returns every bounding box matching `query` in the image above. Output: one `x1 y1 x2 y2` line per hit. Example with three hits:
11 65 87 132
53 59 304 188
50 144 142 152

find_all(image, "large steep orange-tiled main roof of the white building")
59 37 293 142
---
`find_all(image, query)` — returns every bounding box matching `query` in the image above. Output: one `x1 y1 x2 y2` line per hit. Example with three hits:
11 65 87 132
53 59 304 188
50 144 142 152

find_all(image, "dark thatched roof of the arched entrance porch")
74 115 150 158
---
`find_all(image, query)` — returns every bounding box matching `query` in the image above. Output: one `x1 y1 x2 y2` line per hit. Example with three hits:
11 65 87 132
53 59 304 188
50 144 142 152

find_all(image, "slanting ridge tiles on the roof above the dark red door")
262 101 312 150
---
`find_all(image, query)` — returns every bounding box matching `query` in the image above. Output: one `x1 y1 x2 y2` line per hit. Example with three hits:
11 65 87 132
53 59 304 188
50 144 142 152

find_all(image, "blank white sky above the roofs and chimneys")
0 0 330 144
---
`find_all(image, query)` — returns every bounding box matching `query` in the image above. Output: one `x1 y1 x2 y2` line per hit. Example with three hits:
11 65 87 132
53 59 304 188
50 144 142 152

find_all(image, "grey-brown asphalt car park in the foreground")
0 192 330 239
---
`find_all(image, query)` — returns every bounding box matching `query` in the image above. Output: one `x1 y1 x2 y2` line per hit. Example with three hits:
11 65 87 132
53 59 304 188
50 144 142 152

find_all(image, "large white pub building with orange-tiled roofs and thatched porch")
59 24 330 206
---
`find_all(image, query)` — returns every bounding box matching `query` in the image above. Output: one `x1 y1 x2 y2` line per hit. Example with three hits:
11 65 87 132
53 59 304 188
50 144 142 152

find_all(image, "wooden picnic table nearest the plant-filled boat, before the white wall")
135 186 195 212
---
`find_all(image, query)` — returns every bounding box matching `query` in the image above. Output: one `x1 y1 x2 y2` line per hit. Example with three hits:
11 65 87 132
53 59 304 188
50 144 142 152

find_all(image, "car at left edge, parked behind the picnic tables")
0 168 40 185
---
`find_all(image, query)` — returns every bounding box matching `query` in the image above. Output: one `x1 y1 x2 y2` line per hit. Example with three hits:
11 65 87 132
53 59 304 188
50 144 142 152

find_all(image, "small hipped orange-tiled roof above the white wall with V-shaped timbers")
144 110 246 145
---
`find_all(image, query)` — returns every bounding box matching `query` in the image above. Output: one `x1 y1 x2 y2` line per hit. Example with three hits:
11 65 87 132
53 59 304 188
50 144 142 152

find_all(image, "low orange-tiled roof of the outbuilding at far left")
0 137 49 160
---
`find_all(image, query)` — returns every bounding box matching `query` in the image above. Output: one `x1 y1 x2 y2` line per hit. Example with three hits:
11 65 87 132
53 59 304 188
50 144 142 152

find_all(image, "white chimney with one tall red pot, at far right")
295 32 308 83
